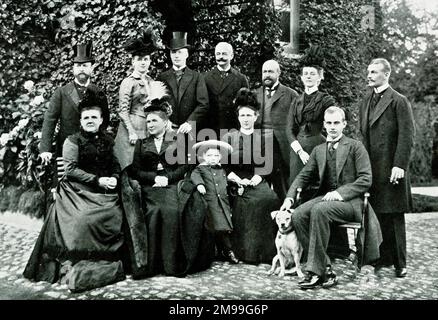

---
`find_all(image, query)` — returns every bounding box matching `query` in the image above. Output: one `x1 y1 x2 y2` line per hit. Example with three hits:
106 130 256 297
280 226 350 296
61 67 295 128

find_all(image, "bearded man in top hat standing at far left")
39 42 109 164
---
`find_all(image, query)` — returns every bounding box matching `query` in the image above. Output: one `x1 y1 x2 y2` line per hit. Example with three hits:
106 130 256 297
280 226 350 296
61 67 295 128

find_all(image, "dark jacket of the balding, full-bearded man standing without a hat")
255 83 298 168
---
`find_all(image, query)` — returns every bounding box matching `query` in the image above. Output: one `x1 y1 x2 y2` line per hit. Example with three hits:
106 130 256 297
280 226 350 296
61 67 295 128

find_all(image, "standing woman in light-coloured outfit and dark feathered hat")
115 28 166 170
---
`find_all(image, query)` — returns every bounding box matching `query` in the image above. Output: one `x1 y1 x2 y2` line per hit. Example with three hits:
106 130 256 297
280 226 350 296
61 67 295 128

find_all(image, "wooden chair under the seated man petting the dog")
294 188 370 270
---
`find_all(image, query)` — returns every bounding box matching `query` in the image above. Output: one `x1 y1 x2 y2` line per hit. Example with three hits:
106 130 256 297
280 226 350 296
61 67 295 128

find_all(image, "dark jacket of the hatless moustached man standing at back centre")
205 67 249 130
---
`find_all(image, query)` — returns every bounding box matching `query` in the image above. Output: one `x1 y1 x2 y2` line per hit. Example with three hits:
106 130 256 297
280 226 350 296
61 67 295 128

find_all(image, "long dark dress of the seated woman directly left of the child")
128 132 211 278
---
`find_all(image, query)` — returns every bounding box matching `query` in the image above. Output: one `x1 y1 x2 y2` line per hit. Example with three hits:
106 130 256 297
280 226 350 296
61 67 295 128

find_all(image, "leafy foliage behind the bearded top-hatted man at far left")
0 0 162 187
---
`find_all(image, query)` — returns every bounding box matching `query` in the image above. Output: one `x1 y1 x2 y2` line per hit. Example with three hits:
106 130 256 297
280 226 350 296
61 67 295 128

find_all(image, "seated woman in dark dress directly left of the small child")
128 101 212 278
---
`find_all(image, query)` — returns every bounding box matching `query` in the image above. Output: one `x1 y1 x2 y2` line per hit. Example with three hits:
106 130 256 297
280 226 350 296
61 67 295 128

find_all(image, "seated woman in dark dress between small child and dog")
223 88 280 263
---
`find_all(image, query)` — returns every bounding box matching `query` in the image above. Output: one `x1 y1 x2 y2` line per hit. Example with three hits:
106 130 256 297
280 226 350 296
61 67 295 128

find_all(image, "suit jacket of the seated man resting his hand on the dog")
287 136 372 217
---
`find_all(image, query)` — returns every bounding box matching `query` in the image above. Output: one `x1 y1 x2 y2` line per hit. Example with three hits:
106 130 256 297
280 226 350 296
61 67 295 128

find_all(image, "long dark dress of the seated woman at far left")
23 132 123 283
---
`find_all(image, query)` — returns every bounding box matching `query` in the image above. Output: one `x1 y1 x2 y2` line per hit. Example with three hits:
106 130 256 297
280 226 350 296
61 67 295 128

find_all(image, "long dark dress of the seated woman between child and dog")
223 131 281 264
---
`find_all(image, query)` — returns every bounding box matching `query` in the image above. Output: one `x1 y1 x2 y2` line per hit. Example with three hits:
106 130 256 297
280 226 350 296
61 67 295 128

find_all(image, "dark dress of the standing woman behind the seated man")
286 91 335 185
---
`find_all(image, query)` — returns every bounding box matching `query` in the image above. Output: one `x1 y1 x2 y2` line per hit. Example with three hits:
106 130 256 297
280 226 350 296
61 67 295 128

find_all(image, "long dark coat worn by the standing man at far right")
359 87 415 213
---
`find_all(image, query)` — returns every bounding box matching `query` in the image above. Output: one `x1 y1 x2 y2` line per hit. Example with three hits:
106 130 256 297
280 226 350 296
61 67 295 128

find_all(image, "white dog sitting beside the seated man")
268 209 304 278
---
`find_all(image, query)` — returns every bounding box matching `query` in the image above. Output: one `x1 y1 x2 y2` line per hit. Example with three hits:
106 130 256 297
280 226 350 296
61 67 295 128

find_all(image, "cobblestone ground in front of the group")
0 213 438 300
